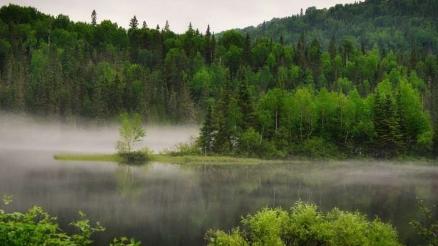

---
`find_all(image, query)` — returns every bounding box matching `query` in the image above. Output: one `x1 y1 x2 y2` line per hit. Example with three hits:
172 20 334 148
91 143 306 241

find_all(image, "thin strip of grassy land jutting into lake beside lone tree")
54 153 283 165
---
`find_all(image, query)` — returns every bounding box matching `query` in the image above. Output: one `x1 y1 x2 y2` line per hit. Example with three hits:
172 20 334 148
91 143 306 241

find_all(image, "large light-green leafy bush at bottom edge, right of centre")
206 202 400 246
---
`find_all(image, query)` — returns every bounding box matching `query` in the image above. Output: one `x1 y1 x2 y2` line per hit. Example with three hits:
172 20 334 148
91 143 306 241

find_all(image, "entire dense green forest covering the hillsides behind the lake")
0 0 438 158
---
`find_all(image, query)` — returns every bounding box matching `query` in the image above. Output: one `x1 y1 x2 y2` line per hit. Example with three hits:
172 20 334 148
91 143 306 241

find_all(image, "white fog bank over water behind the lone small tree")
0 112 199 153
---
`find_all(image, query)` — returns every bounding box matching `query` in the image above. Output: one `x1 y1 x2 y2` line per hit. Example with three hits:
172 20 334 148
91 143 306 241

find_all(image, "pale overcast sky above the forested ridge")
0 0 358 32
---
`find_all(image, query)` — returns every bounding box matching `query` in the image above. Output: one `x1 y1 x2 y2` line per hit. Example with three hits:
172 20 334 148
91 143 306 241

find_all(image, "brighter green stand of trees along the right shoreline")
199 73 437 158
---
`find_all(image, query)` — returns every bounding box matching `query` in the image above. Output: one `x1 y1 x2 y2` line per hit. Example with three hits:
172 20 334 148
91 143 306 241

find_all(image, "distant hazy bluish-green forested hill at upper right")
241 0 438 51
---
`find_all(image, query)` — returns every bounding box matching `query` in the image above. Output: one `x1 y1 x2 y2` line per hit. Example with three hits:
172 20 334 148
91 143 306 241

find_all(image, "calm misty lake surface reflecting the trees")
0 150 438 245
